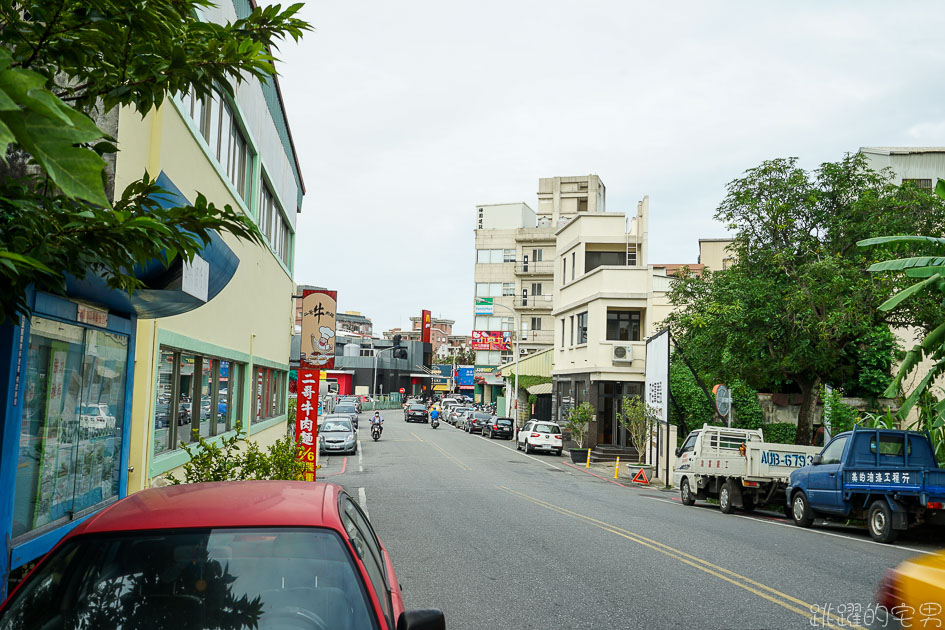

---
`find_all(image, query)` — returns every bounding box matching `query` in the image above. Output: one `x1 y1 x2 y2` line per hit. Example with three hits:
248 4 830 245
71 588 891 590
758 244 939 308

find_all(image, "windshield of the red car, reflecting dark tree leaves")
0 528 377 630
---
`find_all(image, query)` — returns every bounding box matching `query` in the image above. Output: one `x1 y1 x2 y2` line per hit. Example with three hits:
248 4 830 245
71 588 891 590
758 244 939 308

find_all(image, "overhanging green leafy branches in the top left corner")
0 0 310 322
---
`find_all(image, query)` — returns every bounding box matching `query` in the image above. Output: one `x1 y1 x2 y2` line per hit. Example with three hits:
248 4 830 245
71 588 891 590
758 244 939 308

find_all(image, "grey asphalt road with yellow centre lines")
319 410 945 630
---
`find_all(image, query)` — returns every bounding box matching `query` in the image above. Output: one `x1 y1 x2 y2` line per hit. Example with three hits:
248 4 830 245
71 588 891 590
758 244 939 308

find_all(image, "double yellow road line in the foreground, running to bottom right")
498 486 866 630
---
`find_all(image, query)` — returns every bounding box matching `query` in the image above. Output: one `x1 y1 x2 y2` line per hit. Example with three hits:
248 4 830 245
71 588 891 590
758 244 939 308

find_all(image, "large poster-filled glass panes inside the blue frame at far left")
13 316 128 540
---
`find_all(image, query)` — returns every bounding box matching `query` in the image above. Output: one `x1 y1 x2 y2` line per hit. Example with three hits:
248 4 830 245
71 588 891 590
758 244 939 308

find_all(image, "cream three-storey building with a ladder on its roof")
552 198 671 446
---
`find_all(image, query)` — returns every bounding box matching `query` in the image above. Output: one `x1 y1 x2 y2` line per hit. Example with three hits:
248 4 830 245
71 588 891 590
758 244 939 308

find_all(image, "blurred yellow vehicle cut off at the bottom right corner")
876 549 945 628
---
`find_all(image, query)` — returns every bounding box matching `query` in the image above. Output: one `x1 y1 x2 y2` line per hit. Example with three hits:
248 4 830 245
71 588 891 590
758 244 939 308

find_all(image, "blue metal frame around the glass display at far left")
0 290 137 595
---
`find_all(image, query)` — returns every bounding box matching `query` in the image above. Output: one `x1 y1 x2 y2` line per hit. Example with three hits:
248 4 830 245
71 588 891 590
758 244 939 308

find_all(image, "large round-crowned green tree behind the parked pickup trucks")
669 154 945 444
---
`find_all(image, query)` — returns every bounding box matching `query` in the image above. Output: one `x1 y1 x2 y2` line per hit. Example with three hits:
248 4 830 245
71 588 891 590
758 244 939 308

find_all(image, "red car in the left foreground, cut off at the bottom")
0 481 446 630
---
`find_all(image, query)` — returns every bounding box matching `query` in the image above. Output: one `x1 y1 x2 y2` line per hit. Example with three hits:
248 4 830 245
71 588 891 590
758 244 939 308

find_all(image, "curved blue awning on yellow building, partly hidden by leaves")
66 171 240 319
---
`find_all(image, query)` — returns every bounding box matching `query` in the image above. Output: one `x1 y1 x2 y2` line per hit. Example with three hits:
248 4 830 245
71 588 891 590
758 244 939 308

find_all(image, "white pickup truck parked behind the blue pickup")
673 424 821 514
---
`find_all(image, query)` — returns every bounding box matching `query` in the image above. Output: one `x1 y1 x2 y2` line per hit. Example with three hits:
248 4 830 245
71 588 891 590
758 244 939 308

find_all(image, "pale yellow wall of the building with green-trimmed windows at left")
115 101 294 494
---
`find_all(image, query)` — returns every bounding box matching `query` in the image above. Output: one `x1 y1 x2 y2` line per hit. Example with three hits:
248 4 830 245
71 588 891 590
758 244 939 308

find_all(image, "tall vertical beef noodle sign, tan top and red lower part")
295 289 338 481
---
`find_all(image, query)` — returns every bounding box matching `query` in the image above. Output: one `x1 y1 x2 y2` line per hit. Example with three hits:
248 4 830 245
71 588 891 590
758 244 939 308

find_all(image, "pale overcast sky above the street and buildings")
280 0 945 334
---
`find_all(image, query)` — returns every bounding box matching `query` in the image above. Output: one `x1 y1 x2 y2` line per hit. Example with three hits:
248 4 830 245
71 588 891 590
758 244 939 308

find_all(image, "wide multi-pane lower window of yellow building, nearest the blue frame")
152 347 246 455
